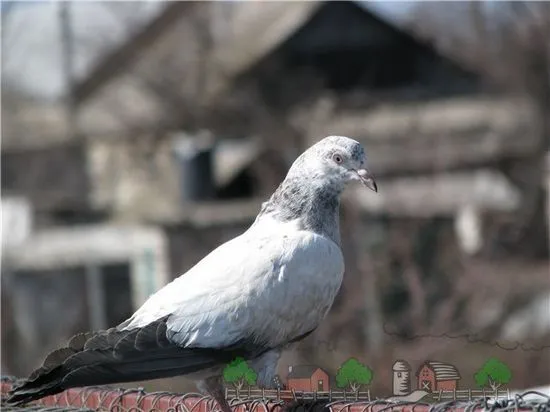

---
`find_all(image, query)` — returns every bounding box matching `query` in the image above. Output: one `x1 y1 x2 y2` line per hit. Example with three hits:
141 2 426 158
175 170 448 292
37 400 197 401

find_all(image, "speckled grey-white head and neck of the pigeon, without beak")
256 136 366 244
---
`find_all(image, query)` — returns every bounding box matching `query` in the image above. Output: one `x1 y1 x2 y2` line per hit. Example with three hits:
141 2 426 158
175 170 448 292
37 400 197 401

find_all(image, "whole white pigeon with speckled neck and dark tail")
7 136 377 412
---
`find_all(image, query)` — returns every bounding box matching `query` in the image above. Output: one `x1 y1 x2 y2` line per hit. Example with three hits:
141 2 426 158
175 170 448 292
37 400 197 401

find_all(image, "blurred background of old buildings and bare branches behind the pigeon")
1 1 550 396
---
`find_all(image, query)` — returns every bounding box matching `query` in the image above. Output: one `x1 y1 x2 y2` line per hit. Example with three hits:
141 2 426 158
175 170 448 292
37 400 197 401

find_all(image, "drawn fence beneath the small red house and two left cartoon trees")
225 387 371 401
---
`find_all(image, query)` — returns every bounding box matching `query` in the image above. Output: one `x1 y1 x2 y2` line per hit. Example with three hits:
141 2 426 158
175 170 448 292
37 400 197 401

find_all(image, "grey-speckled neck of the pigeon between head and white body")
259 175 343 245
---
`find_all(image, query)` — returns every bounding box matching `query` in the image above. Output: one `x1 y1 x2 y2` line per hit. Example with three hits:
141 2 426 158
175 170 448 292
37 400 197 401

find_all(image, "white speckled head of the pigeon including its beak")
300 136 378 192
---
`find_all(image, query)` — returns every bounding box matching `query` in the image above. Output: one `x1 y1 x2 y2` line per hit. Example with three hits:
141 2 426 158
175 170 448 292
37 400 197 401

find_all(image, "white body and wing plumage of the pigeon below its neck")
125 216 344 348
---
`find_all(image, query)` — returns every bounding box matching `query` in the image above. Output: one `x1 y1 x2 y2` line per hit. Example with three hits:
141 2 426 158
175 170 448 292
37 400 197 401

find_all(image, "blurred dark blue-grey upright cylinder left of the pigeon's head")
173 132 215 203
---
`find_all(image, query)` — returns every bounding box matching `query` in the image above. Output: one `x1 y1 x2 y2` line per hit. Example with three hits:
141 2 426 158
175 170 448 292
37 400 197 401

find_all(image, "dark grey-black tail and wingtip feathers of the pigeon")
7 316 269 405
